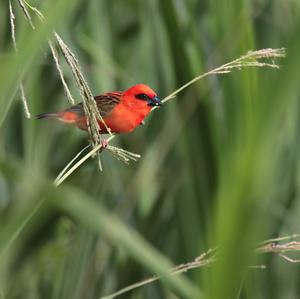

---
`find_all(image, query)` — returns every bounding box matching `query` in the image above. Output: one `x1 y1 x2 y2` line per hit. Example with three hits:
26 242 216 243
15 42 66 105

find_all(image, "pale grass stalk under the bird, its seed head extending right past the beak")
55 48 286 186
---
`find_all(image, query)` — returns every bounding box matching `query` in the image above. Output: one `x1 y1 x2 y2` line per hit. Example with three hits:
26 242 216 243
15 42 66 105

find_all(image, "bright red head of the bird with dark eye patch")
124 84 162 110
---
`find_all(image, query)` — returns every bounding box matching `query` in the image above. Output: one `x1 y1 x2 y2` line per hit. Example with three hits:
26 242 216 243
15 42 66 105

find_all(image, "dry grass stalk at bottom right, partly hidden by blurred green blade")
100 234 300 299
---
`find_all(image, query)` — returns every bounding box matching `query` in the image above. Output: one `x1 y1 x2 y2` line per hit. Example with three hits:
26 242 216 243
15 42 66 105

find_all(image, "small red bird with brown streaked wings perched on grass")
37 84 162 134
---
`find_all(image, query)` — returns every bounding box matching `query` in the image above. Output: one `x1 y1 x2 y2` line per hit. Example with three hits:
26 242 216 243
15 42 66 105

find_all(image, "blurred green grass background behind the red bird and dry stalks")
0 0 300 299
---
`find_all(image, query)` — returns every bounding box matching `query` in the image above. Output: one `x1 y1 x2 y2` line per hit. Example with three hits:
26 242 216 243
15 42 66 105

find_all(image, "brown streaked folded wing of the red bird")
65 92 122 117
